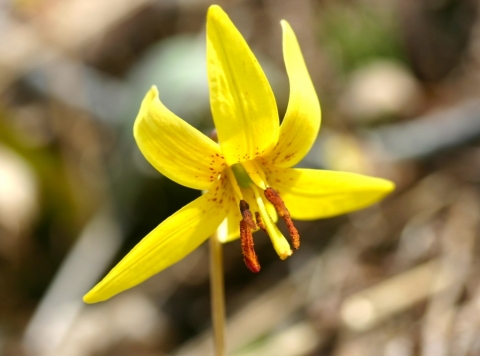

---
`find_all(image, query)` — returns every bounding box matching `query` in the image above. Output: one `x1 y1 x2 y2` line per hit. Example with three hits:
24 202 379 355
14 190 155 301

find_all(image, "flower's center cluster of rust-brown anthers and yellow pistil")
227 161 300 272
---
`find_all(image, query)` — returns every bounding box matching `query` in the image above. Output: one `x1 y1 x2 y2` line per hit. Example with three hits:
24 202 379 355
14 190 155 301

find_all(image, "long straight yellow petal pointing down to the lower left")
83 179 231 303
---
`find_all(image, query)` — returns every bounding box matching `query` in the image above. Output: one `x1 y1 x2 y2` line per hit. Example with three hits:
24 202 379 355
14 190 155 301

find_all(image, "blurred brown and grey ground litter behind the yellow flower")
0 0 480 356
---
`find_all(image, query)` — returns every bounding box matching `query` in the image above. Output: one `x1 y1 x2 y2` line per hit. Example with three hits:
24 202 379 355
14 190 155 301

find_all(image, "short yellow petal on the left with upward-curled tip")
133 86 226 189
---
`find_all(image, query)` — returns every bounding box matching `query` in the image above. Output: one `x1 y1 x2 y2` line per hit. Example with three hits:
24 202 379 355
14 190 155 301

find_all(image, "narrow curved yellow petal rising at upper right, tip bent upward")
265 21 321 167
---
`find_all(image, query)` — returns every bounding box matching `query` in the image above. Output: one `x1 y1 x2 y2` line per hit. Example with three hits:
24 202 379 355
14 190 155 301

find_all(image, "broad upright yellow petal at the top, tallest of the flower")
207 5 279 165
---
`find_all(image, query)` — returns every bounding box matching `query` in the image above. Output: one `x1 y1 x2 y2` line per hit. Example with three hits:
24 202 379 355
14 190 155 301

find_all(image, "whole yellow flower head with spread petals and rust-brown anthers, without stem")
84 5 394 303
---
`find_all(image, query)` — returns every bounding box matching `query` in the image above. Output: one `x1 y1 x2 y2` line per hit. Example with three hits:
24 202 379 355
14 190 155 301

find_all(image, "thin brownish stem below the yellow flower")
209 229 226 356
